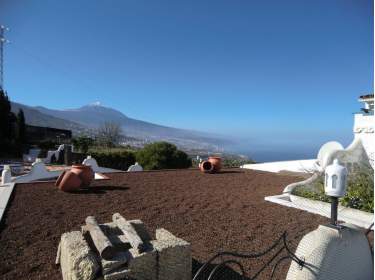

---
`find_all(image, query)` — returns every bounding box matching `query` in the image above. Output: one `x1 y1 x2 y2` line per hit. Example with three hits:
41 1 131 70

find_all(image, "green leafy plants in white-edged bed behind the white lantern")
292 166 374 213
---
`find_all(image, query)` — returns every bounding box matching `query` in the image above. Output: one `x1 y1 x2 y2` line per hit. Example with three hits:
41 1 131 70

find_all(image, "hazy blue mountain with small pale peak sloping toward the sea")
12 103 229 150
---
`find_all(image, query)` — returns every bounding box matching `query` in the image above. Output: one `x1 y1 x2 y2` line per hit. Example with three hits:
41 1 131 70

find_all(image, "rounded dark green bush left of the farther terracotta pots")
137 142 192 170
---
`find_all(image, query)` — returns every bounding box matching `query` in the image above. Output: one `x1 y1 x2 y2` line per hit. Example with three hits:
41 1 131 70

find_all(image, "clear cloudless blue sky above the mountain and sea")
0 0 373 160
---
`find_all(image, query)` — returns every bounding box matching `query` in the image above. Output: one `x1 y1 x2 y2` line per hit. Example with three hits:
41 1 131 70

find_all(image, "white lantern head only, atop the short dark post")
324 159 348 197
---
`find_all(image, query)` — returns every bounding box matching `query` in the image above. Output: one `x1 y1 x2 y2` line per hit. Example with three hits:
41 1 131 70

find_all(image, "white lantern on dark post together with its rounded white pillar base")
286 159 374 280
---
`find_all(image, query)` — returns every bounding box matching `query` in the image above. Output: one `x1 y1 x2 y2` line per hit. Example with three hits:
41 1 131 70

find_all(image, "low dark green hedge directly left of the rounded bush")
91 150 135 170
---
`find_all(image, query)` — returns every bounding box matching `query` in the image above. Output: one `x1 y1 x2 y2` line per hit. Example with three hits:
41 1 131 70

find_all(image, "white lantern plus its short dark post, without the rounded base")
324 159 348 226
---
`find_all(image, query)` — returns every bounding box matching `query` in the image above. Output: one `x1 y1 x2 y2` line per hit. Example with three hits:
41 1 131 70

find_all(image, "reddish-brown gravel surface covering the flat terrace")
0 169 356 280
